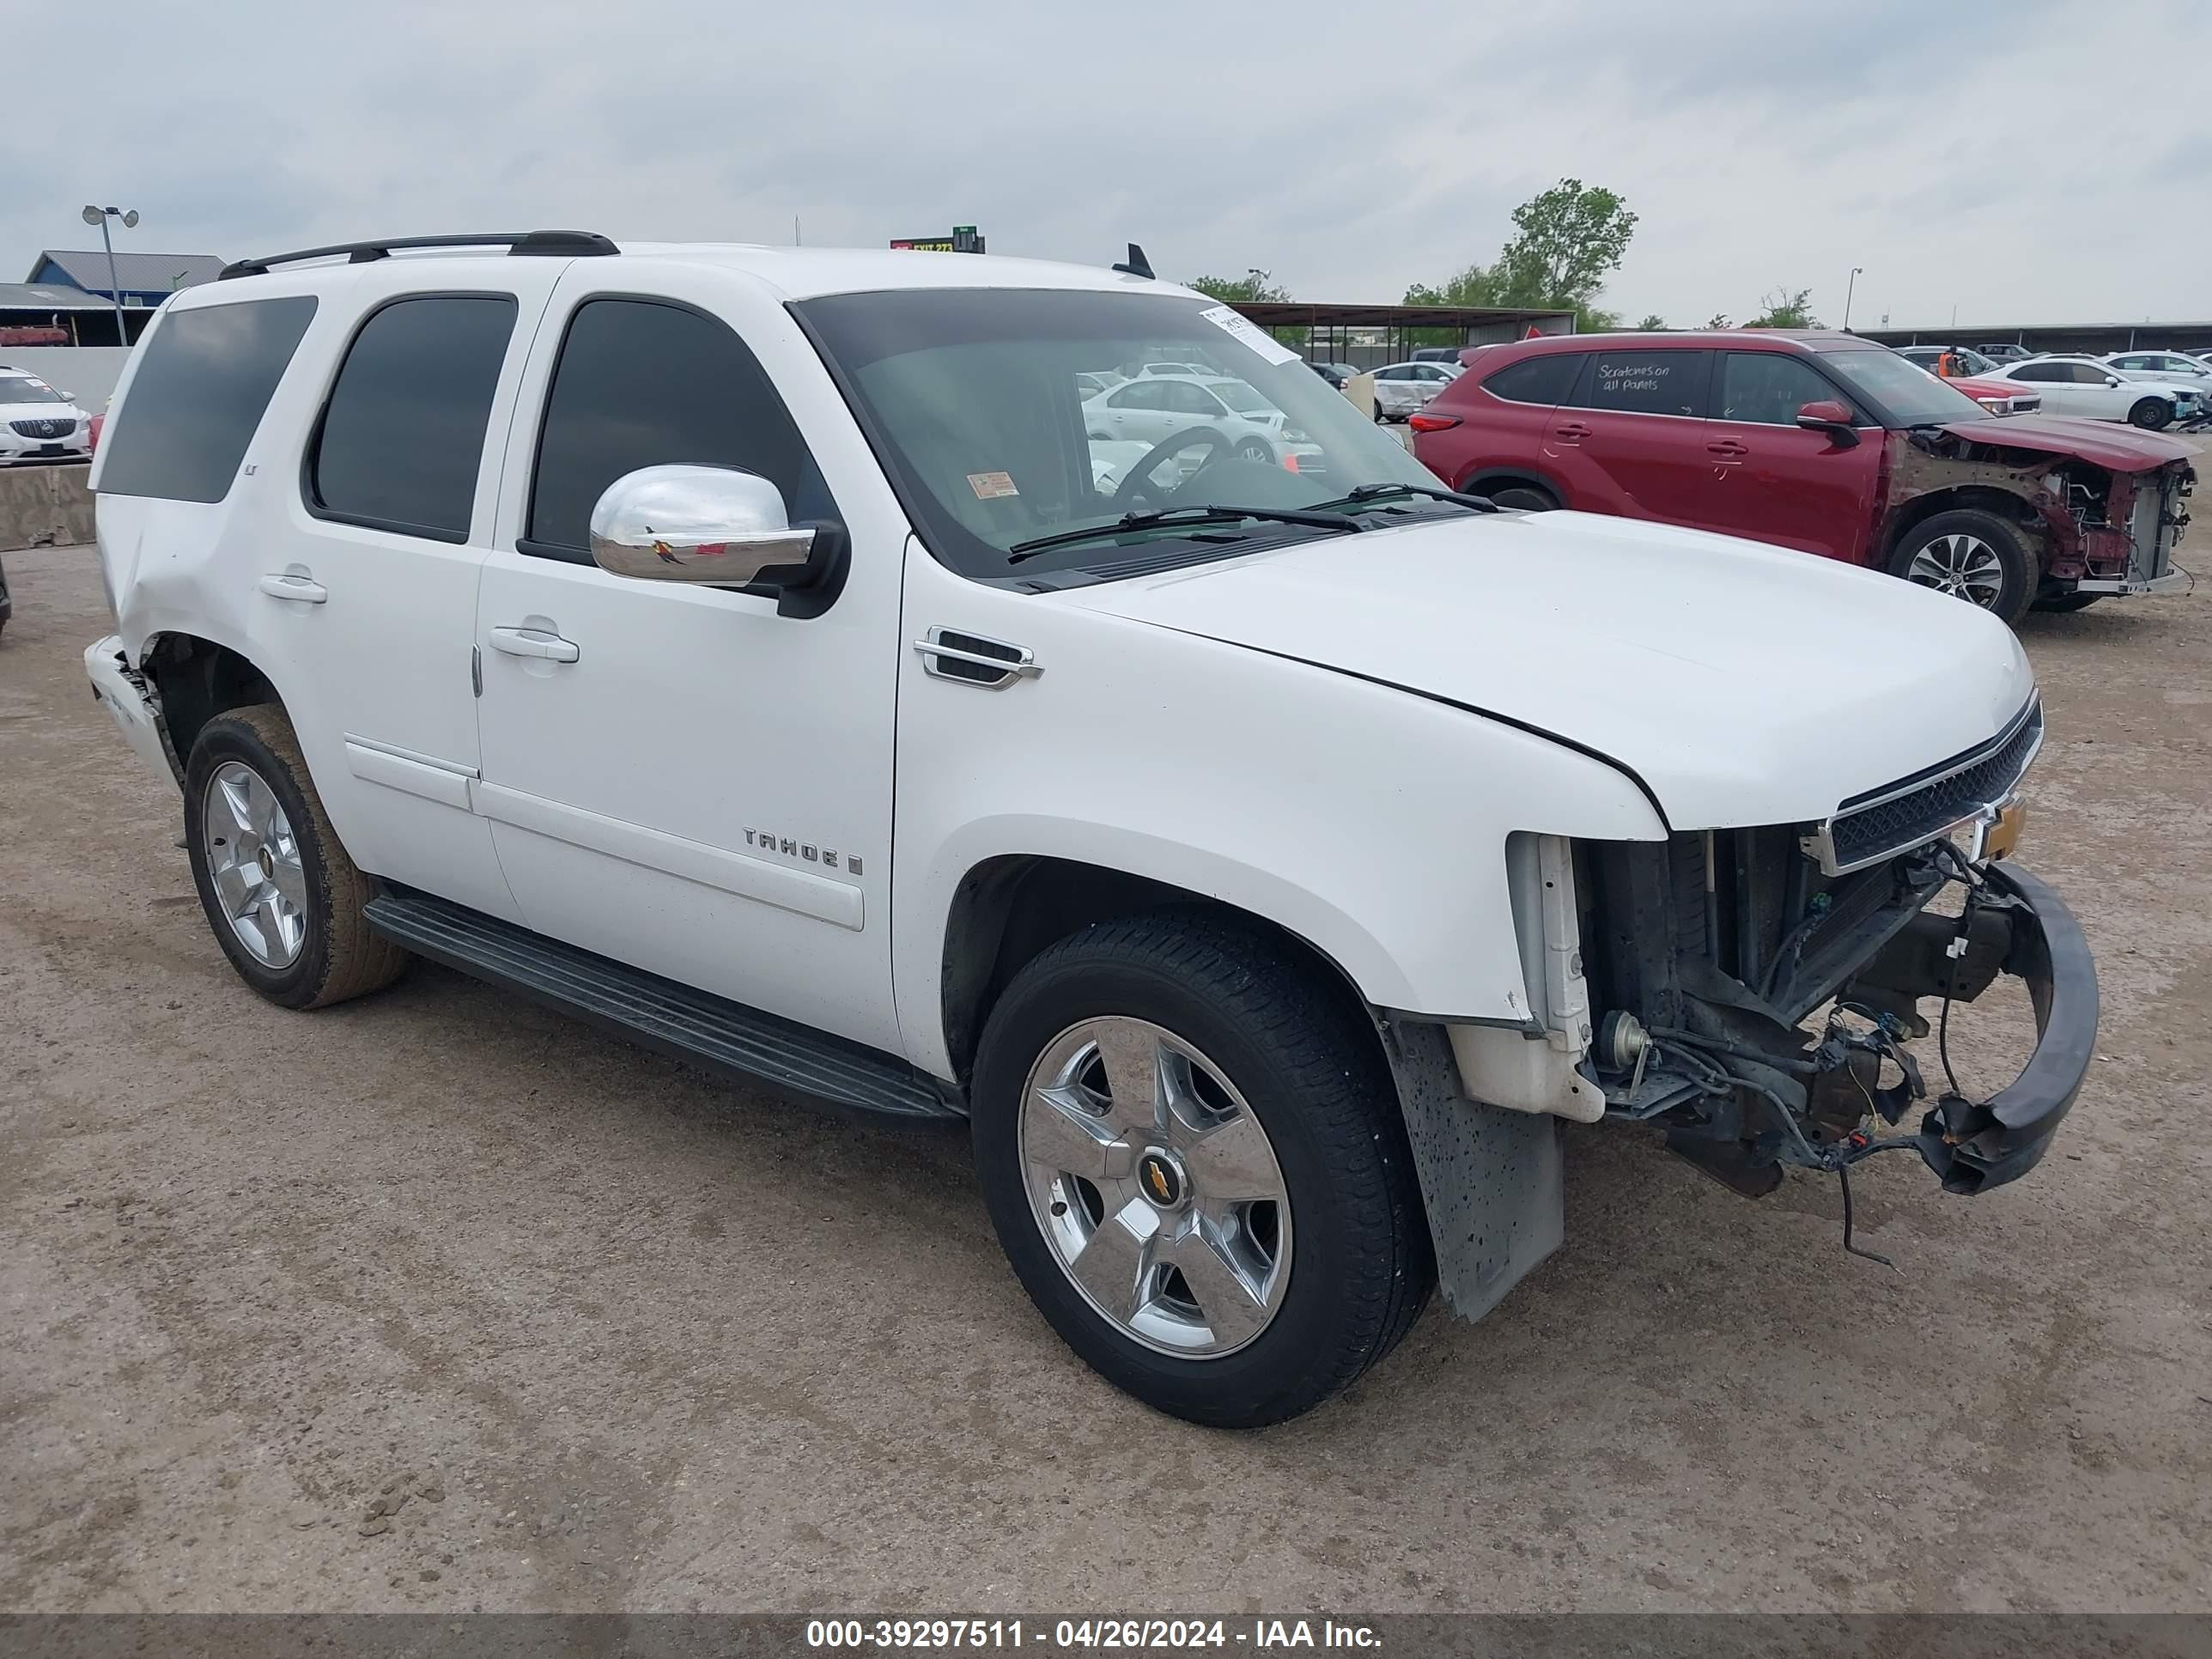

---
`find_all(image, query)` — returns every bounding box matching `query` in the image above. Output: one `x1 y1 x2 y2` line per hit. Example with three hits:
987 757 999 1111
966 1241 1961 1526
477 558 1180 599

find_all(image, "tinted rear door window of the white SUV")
307 295 515 542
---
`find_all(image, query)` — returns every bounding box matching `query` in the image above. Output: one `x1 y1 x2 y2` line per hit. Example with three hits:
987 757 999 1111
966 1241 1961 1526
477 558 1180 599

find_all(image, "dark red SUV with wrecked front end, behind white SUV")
1411 330 2197 622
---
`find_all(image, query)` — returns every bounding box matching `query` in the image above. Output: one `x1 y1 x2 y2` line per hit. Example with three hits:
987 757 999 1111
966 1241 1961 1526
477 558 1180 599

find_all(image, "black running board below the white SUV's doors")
368 883 967 1121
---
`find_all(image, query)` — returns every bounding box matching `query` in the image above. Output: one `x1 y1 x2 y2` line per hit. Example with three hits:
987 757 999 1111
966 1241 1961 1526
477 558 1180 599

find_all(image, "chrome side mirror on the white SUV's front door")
591 467 817 588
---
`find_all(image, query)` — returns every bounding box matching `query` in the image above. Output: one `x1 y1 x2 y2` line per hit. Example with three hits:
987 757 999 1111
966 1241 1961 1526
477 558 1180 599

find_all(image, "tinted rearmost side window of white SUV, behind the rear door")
100 295 314 502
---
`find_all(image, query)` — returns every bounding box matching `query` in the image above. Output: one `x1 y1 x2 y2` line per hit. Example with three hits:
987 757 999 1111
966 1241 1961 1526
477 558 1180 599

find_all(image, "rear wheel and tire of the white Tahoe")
184 703 410 1009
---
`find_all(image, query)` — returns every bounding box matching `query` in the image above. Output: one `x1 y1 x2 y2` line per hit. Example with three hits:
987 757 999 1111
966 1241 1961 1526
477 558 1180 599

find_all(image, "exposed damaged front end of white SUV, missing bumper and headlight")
1571 699 2097 1255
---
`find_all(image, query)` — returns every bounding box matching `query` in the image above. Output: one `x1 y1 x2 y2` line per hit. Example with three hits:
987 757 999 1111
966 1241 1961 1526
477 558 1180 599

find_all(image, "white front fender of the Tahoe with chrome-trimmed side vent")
891 549 1666 1075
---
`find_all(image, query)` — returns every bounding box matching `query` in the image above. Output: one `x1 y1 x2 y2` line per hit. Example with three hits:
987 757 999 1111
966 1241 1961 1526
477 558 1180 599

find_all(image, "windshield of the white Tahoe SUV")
792 288 1462 577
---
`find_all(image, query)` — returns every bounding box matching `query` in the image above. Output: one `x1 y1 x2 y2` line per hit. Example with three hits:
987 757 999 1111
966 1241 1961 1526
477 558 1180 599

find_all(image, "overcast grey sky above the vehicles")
17 0 2212 327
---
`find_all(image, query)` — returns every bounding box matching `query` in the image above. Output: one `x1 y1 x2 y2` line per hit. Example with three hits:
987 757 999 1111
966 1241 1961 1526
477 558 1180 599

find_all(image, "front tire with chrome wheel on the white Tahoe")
971 911 1436 1429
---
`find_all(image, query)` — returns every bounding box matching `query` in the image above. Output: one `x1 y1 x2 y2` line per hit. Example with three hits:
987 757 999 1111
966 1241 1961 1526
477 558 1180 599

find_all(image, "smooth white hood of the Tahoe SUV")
1055 514 2035 830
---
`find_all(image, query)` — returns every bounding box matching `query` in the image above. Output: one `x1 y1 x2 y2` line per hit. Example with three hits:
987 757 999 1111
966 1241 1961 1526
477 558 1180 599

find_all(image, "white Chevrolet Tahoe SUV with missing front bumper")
86 232 2097 1425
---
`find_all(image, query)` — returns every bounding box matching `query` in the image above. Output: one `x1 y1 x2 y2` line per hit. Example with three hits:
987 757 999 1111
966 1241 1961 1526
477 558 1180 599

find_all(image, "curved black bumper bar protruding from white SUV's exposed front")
1916 865 2097 1194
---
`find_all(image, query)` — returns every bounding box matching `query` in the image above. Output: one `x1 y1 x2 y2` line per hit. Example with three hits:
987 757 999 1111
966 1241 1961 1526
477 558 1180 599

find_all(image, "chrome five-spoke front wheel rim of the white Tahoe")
1020 1015 1290 1358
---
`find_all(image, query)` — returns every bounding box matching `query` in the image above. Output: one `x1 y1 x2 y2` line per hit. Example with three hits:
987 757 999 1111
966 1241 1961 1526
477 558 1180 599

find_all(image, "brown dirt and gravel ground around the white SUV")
0 549 2212 1614
